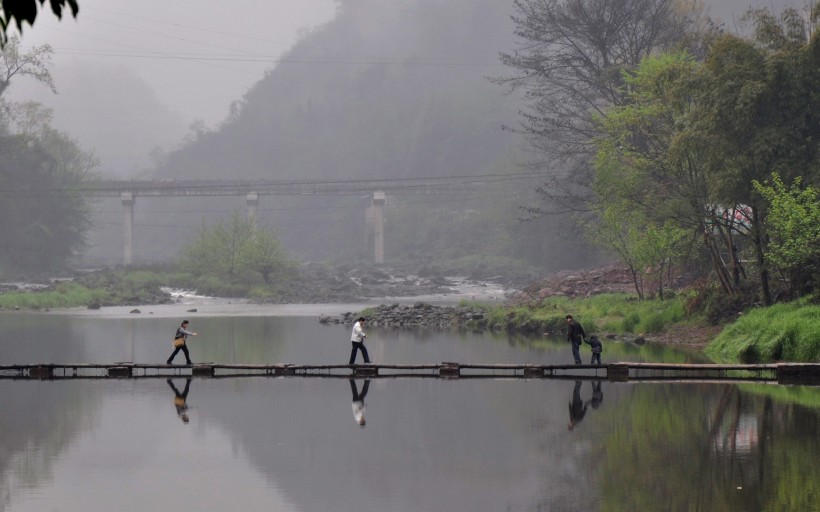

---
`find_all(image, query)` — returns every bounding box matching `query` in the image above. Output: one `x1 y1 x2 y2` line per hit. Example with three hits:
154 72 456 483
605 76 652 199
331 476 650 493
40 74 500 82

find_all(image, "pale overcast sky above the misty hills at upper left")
10 0 336 126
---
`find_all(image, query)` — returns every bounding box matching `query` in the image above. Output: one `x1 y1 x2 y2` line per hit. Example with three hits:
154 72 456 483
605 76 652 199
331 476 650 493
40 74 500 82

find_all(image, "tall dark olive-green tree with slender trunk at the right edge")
692 9 820 304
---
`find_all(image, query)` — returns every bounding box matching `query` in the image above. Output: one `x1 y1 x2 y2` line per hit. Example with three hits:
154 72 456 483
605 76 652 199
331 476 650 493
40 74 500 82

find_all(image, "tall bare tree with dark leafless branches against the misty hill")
495 0 710 215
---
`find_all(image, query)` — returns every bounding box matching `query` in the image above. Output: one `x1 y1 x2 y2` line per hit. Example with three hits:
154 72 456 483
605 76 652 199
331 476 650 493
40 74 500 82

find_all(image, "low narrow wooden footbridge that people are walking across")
0 362 820 385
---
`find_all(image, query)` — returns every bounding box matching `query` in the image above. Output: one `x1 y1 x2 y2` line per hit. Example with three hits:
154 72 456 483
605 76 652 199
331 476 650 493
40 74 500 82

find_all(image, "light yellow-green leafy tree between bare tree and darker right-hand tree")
592 53 714 297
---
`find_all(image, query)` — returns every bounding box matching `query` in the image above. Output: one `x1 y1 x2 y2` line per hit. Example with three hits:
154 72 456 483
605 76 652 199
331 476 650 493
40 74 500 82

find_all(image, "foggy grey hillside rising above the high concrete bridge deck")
157 0 518 179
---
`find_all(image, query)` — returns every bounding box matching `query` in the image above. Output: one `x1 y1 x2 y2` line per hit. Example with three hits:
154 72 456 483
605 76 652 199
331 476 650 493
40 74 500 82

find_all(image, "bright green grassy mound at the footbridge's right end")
706 299 820 362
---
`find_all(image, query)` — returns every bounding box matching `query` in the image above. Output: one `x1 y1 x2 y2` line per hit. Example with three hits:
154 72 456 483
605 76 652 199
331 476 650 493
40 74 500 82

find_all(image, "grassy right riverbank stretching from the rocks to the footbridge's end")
464 293 820 363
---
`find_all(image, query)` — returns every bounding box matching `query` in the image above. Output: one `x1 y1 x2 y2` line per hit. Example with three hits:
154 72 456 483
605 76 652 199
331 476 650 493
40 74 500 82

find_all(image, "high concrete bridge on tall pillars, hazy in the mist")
80 172 542 265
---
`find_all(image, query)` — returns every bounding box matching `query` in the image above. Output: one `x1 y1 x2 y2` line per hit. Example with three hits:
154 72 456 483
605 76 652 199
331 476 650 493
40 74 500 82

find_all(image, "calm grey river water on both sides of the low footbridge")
0 308 820 512
